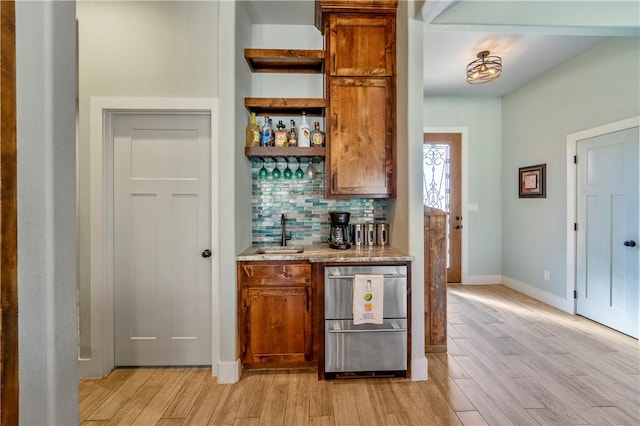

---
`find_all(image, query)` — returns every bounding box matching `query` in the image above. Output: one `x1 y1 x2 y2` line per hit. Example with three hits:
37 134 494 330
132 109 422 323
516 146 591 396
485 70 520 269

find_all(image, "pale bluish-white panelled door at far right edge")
576 127 640 338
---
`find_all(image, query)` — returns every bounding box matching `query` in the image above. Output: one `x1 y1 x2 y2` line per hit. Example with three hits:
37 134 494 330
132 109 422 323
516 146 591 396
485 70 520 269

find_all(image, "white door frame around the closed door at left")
79 97 220 377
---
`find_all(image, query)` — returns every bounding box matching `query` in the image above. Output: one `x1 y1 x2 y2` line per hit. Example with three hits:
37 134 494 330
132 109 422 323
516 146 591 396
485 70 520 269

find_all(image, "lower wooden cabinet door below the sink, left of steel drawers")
242 287 312 365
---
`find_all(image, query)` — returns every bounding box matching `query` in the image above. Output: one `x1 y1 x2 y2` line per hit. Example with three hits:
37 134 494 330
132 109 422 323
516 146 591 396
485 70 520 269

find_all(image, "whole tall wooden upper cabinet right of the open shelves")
316 0 398 198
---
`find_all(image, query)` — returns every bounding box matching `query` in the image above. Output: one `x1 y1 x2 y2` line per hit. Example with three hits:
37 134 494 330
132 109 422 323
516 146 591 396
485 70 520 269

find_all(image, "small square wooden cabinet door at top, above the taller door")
328 14 396 76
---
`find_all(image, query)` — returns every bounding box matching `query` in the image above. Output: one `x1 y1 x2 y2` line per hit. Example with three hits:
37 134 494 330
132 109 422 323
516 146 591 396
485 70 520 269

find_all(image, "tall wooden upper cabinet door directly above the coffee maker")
325 78 395 198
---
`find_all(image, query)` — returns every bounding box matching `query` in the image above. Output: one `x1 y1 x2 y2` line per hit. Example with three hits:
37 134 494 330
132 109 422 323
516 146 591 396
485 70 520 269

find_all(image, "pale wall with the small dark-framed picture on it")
502 37 640 308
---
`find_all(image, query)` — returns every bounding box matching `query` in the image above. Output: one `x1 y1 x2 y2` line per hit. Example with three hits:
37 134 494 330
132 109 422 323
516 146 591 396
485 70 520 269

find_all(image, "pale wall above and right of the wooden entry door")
423 97 503 284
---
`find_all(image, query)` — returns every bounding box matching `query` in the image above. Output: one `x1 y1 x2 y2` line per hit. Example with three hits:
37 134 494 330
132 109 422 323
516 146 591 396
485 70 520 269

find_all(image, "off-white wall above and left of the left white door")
77 1 220 358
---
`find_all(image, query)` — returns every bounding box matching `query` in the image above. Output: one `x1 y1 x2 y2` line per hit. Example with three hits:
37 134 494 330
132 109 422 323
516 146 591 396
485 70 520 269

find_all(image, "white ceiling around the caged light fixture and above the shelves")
242 0 640 96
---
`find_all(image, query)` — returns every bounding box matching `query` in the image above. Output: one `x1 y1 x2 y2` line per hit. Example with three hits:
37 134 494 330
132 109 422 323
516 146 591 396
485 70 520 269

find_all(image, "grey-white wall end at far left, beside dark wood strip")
16 2 78 425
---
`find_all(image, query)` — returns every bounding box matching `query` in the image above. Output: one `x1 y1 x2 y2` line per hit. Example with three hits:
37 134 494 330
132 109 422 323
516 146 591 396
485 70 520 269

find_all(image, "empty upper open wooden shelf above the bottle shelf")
244 49 324 74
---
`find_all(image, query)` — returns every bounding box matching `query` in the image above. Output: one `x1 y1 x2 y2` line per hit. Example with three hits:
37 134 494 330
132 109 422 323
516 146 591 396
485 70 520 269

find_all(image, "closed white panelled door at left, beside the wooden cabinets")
112 113 212 366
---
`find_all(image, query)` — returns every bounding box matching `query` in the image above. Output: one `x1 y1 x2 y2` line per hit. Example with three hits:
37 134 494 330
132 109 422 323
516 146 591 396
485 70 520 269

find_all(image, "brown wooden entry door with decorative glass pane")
422 133 462 283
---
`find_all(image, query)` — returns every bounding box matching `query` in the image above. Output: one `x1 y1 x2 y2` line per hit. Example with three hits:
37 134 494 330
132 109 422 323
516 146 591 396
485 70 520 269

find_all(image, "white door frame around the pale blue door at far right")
566 116 640 315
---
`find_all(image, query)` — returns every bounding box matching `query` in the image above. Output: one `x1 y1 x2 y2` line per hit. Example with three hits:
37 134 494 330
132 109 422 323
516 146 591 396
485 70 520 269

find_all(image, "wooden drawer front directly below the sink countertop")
238 262 311 287
